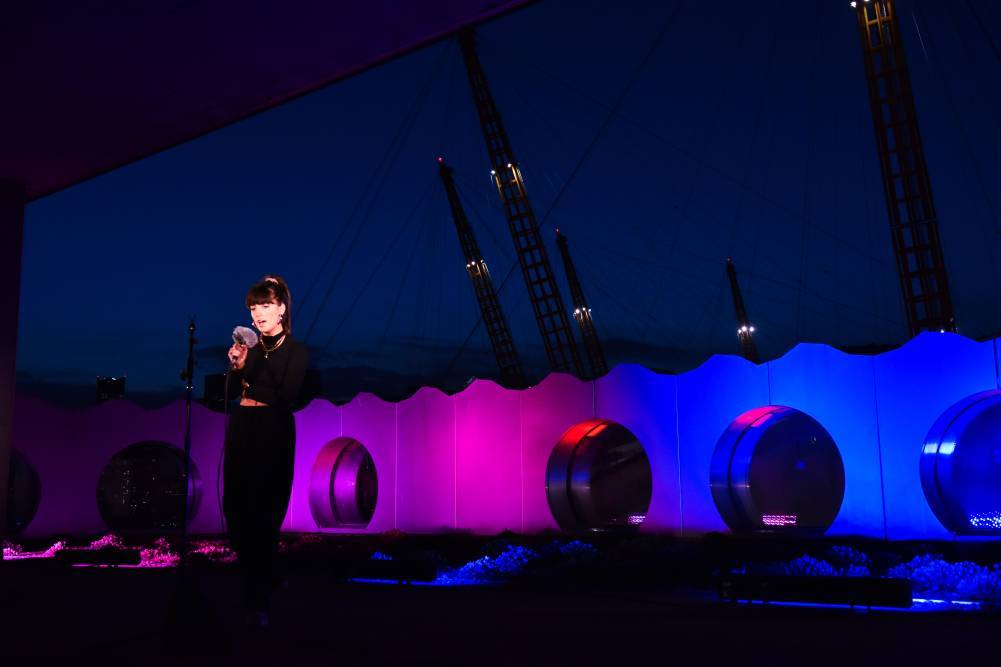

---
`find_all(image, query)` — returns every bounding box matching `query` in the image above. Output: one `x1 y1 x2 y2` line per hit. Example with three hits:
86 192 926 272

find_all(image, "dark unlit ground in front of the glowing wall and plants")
0 532 1001 667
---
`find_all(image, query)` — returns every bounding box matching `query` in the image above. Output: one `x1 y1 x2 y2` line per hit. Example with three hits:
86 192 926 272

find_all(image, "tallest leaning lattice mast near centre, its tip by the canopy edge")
458 29 583 377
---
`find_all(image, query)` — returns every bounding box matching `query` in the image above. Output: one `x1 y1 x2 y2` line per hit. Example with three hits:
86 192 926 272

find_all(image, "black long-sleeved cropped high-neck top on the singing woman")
229 334 309 410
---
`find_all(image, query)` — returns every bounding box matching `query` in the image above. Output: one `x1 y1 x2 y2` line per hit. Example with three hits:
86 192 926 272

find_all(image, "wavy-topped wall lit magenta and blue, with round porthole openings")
14 334 1001 539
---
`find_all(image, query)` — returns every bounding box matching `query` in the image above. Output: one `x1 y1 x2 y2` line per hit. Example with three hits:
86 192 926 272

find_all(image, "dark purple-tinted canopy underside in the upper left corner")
0 0 529 200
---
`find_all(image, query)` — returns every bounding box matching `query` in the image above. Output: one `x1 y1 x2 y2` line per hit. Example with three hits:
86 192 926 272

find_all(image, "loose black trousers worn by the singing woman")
222 406 295 609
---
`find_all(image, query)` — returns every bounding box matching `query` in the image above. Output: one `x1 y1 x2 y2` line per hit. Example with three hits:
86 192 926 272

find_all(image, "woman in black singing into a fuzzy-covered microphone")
222 275 308 626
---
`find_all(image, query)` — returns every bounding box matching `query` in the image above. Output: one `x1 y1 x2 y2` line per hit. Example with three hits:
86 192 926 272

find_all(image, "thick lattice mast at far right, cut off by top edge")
851 0 956 337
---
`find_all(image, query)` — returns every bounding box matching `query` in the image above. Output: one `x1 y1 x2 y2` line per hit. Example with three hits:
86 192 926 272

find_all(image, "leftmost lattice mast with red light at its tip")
437 155 528 389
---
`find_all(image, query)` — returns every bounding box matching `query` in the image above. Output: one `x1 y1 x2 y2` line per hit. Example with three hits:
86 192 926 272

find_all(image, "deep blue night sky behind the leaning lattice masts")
18 0 1001 405
